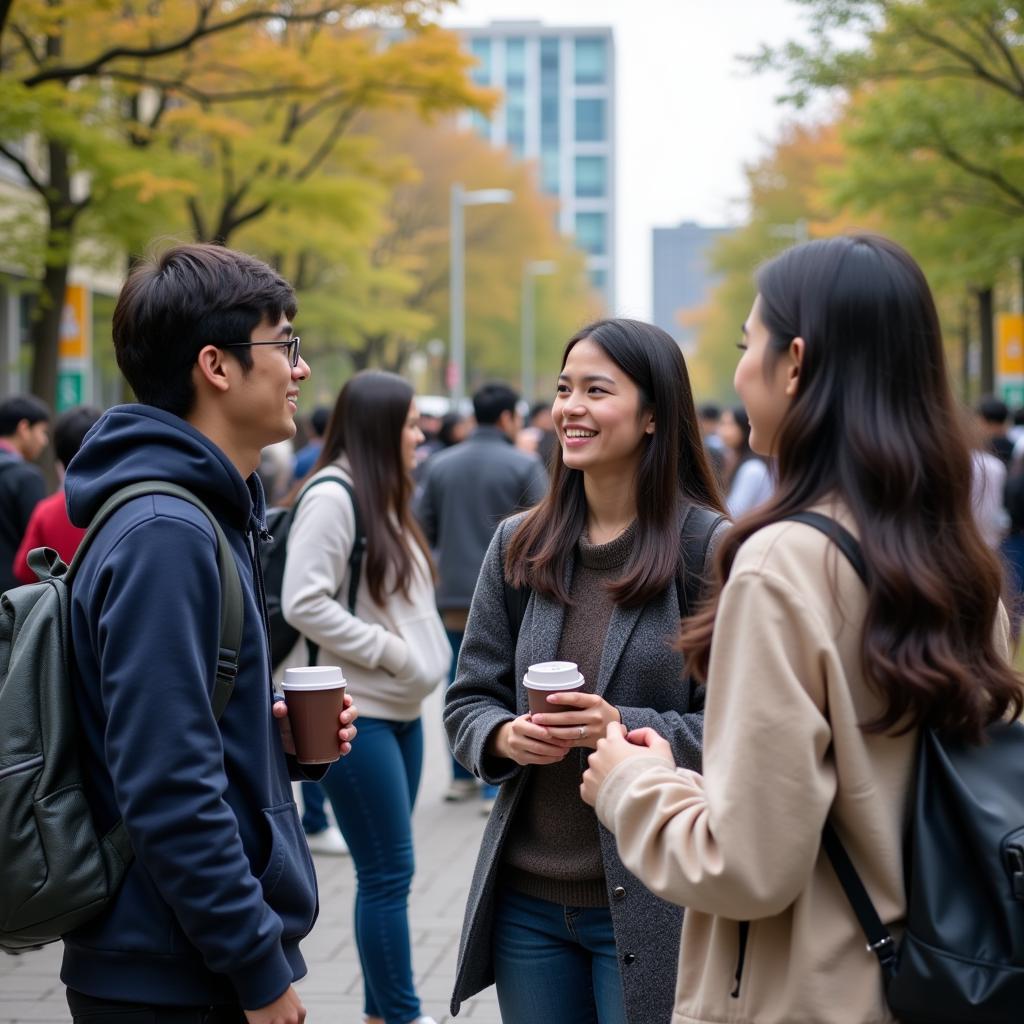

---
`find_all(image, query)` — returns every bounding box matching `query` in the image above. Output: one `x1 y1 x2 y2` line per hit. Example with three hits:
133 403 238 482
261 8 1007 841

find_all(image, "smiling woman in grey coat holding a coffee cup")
442 319 724 1024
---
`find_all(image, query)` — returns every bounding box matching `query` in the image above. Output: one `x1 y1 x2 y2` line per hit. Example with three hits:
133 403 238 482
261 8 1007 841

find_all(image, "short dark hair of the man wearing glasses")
114 245 296 416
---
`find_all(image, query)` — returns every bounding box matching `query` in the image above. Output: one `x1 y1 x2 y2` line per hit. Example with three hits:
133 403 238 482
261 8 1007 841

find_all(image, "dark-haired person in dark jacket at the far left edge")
0 394 50 593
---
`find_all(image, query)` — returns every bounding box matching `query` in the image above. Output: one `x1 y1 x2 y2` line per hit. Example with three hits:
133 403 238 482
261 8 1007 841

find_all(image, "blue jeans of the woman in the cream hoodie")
321 716 423 1024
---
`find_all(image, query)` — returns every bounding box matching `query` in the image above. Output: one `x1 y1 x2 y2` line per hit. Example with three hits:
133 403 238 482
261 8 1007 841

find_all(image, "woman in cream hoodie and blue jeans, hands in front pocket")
282 371 452 1024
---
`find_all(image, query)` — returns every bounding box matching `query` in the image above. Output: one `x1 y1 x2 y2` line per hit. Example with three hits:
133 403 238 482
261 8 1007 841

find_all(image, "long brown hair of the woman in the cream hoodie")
313 370 432 605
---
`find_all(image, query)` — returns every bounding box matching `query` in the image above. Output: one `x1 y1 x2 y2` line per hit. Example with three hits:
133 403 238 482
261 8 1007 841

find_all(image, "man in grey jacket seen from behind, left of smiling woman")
416 384 547 812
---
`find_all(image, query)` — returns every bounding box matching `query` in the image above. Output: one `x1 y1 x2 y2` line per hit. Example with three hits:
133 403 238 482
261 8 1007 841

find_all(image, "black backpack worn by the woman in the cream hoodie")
259 476 367 669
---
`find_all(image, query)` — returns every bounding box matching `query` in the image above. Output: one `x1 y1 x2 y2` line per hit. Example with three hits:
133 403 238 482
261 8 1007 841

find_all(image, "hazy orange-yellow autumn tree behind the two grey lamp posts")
272 105 599 389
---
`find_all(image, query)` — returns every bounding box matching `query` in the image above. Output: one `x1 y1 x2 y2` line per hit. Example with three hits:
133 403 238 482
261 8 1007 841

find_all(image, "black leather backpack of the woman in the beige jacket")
786 512 1024 1024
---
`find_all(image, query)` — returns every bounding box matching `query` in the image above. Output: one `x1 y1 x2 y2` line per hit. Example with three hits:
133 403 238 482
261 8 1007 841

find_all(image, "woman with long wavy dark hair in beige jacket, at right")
583 236 1022 1024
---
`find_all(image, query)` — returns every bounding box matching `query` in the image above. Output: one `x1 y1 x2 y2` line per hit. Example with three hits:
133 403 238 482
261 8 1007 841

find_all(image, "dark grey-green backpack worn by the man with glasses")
0 480 244 952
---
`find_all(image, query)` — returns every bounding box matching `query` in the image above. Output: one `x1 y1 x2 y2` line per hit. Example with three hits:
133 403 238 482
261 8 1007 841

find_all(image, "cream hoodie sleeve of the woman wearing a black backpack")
282 483 409 675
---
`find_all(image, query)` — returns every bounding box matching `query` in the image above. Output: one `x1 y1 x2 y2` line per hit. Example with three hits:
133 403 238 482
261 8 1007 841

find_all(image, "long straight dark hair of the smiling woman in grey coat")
505 319 724 607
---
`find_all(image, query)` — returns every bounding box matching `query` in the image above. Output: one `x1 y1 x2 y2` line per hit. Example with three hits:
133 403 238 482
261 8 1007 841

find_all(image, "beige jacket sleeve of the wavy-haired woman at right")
597 569 837 921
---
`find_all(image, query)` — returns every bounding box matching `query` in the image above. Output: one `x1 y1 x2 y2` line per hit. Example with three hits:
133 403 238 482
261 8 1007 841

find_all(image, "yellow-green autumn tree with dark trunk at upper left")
0 0 486 411
